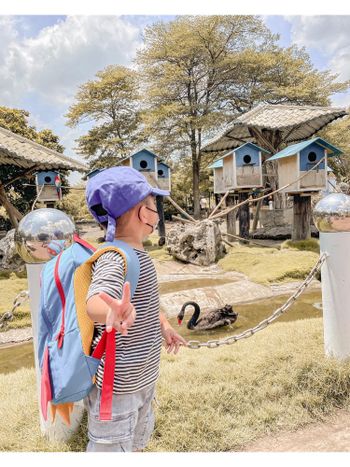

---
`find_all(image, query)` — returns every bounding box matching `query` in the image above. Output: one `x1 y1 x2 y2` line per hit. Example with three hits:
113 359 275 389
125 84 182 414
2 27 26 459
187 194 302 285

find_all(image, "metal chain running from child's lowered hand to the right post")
187 253 328 349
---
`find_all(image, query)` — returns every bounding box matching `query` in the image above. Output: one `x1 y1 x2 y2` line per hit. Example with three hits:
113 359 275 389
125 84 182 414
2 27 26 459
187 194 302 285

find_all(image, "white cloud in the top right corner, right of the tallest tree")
285 15 350 80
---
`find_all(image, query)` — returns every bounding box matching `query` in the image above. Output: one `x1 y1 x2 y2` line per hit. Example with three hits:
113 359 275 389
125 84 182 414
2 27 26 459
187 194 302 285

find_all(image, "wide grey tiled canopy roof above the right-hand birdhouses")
202 104 348 152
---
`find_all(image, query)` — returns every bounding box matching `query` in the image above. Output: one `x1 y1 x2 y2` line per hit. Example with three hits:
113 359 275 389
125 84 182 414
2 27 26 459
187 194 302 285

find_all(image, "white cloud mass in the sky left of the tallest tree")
0 16 140 108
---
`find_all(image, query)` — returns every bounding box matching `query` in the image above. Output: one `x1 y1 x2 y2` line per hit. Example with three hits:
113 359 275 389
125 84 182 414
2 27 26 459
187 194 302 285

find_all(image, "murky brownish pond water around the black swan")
0 290 322 374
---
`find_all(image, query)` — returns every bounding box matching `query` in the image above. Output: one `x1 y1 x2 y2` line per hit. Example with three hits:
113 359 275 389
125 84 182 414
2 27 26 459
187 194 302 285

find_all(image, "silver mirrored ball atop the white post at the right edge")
313 193 350 232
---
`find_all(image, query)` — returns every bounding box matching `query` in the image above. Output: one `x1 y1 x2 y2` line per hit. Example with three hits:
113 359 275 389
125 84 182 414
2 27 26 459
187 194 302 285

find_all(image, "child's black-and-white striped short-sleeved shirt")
87 248 162 394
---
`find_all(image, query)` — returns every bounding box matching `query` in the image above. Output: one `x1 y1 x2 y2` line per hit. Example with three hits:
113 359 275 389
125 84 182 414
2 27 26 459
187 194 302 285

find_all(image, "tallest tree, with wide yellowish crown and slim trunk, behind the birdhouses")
137 16 348 217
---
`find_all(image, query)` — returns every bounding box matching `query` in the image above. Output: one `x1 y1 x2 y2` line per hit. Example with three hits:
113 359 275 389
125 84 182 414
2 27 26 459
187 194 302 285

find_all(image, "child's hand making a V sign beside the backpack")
99 282 136 336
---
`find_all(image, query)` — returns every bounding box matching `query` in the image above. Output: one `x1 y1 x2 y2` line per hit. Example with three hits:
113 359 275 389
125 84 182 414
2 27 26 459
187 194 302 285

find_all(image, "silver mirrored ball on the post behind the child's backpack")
15 208 75 263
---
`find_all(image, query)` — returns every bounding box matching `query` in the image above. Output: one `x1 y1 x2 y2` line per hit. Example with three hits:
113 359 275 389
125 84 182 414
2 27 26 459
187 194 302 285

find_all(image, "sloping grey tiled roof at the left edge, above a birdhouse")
0 127 88 172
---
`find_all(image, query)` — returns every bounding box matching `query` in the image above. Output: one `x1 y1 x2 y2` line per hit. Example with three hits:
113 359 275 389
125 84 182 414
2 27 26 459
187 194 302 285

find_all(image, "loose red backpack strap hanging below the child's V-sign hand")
92 329 116 420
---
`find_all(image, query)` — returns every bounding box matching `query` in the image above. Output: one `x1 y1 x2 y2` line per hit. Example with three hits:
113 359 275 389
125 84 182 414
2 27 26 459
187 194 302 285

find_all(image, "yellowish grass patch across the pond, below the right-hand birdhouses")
218 245 319 284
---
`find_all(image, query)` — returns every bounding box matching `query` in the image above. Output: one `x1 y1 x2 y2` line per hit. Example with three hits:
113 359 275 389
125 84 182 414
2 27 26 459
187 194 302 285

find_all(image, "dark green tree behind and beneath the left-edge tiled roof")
0 106 68 229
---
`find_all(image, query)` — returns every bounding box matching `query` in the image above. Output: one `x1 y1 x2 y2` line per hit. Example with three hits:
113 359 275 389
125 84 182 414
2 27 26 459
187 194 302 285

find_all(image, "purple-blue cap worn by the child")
86 167 170 242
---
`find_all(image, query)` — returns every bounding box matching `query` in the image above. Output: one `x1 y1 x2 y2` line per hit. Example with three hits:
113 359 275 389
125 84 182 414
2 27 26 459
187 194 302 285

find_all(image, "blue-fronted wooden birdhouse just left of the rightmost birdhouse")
209 143 270 193
